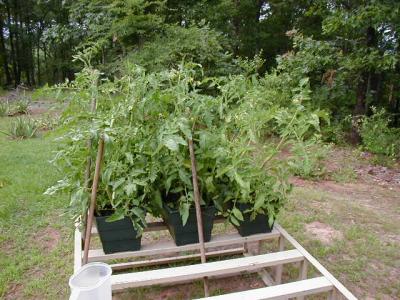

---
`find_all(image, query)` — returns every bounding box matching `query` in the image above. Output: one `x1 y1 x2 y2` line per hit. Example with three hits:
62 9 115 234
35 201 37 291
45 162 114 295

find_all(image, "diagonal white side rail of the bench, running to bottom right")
274 224 357 300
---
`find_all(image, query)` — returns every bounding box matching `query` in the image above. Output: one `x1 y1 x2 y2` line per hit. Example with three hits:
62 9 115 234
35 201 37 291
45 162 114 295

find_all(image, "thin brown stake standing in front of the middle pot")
189 139 209 297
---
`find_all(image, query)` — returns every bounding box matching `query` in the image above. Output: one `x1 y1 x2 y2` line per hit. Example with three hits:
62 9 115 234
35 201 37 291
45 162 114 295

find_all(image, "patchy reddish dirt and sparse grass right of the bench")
282 150 400 299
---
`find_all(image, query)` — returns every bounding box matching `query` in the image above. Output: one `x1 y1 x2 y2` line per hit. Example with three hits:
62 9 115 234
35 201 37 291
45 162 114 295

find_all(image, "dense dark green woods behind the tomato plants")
0 0 400 148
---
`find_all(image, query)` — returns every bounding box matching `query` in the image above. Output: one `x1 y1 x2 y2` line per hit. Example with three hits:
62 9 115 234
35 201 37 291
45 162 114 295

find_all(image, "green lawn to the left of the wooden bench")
0 118 72 299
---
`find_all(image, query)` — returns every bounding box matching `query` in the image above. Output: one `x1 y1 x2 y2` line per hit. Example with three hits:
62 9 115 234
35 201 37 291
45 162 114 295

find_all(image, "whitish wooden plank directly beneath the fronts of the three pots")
89 229 280 262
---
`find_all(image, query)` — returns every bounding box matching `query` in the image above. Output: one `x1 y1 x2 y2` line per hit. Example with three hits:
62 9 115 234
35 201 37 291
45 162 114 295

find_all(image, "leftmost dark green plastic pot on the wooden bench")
96 214 142 254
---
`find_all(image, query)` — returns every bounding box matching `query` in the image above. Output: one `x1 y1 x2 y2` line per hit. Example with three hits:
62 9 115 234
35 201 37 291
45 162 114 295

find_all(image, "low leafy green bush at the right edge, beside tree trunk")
360 108 400 157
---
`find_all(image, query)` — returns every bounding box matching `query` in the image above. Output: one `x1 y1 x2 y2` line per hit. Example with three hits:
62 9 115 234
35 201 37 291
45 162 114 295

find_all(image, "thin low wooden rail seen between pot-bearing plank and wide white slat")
110 248 244 270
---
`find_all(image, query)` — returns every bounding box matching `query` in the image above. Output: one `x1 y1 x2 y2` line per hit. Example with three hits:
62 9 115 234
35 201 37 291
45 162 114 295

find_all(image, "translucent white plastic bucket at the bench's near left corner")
69 262 112 300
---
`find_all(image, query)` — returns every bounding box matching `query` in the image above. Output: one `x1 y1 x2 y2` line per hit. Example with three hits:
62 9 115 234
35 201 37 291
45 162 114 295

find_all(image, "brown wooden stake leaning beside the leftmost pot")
83 138 104 264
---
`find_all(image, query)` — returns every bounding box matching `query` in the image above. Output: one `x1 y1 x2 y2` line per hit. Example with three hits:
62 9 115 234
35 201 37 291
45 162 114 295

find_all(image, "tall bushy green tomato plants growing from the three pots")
47 52 323 230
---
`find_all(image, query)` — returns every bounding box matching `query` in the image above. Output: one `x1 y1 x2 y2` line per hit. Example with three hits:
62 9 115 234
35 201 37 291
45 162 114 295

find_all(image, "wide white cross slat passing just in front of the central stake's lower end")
111 250 304 290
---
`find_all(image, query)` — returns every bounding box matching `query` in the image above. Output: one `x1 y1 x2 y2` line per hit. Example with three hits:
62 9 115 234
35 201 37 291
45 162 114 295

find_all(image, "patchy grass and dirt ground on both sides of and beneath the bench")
0 111 400 299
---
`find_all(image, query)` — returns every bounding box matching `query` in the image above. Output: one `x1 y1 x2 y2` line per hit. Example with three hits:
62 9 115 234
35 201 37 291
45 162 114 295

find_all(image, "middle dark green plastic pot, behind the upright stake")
163 205 215 246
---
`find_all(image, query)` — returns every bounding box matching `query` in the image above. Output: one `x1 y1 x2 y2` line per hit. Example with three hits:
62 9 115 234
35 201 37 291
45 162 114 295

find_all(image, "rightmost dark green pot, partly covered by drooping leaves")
232 203 273 236
